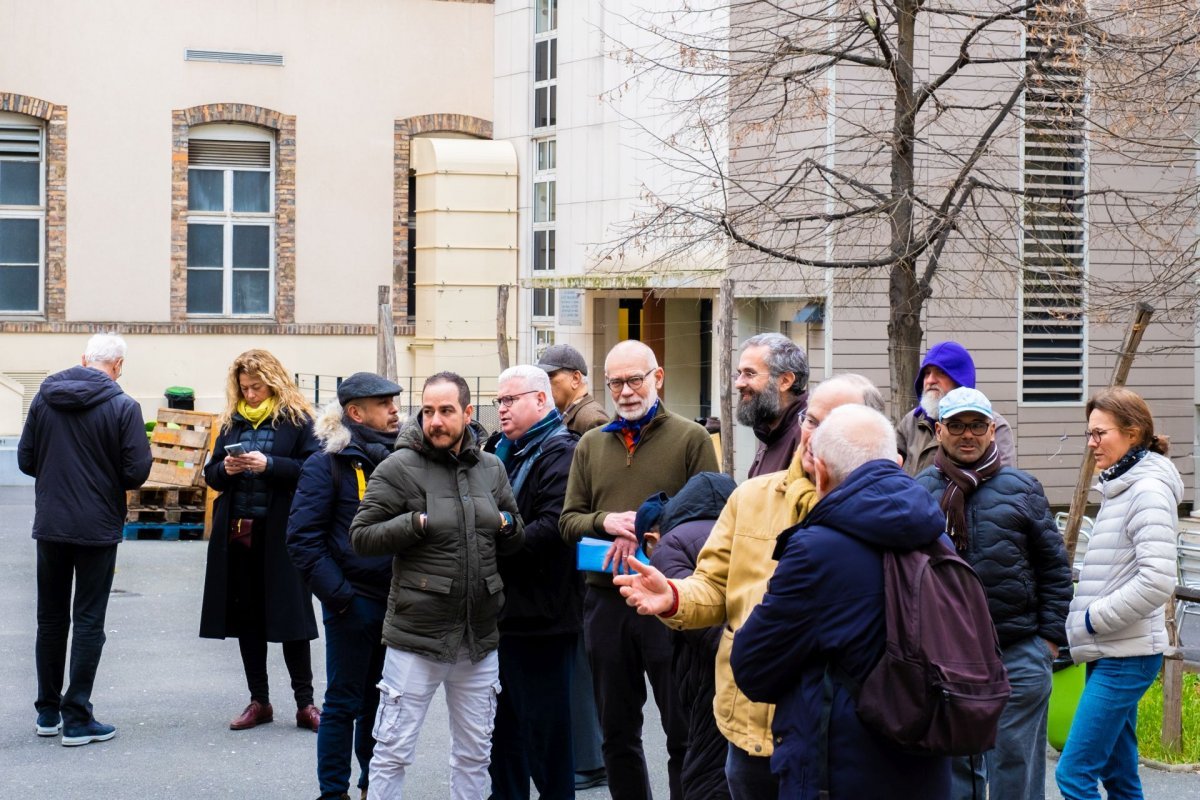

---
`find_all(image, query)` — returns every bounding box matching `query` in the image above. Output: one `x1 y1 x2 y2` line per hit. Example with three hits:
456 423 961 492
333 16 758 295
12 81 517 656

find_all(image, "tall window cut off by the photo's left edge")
0 120 46 313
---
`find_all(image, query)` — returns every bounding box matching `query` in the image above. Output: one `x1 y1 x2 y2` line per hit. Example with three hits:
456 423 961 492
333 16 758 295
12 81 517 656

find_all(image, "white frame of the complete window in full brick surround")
186 125 278 319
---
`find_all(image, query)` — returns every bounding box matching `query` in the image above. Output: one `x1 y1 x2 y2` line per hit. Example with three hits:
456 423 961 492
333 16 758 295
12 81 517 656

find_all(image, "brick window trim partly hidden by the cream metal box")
391 113 492 326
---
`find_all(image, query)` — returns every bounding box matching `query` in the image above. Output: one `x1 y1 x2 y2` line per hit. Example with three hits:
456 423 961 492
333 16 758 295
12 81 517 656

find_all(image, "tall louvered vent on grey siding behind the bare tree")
1021 7 1087 403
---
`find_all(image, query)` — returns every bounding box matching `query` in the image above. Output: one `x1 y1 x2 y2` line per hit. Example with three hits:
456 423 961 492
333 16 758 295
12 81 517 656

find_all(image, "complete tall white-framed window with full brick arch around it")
187 125 275 317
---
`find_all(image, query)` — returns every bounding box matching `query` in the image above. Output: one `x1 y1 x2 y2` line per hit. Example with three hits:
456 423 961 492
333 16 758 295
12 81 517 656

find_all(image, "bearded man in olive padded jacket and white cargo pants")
350 372 524 800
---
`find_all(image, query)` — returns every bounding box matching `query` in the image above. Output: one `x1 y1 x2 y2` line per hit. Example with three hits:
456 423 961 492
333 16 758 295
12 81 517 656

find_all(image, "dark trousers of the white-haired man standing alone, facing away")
34 540 116 728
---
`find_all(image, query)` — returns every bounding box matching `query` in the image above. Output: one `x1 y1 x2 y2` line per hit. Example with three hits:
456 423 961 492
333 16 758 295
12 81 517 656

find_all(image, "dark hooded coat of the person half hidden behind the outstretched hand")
650 473 736 800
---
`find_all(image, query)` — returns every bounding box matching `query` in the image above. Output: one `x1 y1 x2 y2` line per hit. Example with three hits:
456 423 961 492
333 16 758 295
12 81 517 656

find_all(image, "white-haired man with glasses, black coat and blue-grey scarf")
490 365 583 800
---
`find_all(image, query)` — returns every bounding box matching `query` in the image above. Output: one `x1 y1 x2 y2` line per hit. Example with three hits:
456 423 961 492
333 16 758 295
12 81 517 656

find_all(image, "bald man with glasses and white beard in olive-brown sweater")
559 339 719 800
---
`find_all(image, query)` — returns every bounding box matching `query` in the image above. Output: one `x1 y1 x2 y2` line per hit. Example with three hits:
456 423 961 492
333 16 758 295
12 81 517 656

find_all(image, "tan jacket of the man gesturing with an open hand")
661 456 816 757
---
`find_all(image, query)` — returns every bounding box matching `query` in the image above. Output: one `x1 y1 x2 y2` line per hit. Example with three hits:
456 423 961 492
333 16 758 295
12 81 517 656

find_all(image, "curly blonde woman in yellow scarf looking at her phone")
200 350 320 730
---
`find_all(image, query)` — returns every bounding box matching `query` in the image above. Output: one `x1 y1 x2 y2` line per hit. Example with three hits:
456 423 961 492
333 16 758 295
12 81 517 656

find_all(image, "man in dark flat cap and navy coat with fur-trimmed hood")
288 372 401 798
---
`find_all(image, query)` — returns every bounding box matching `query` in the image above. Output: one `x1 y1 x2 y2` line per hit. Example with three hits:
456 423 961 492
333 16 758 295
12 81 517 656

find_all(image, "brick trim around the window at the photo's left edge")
0 91 67 325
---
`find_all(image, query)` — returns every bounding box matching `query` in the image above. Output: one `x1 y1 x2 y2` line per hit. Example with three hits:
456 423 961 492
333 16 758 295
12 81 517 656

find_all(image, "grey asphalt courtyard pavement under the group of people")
0 487 1200 800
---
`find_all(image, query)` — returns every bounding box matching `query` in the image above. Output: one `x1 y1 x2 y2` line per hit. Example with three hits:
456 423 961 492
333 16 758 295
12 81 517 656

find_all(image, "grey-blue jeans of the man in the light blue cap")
950 636 1052 800
